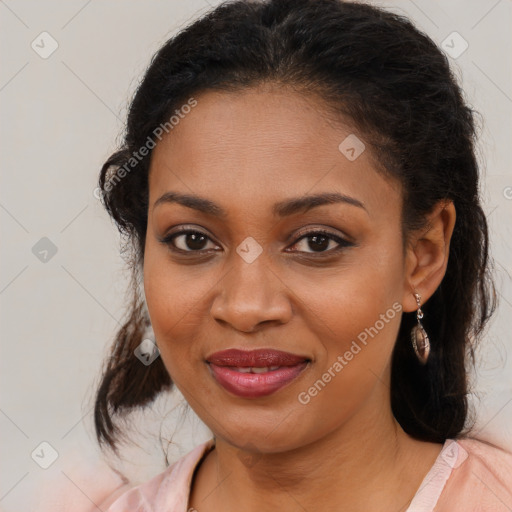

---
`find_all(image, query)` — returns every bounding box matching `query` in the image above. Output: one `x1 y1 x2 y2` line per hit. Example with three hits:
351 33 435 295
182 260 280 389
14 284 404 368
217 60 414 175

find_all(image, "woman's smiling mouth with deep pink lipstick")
206 349 311 398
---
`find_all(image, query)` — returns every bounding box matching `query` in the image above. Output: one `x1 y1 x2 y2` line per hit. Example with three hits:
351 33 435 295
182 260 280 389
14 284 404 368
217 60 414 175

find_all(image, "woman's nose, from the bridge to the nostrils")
211 255 293 333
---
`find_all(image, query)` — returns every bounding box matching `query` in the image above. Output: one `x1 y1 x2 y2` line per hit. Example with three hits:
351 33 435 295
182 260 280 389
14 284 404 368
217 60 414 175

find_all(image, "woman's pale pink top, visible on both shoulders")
101 438 512 512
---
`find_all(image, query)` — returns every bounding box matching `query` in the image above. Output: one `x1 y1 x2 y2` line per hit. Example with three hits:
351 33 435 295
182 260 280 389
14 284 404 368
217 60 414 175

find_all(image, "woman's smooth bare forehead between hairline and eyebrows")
149 87 400 220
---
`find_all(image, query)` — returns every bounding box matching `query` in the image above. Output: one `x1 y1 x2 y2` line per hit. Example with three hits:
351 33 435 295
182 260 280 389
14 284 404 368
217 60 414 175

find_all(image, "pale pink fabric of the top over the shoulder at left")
106 439 214 512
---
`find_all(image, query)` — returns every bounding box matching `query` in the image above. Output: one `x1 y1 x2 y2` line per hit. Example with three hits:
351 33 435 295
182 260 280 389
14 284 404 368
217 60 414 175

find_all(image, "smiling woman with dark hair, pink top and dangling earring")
87 0 512 512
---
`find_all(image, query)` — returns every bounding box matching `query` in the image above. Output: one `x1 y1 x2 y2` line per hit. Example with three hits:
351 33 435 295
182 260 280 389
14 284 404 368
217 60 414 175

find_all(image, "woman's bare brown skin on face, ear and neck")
144 85 455 512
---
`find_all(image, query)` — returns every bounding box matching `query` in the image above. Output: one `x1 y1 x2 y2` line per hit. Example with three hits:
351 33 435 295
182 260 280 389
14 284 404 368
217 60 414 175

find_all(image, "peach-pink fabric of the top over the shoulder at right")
435 437 512 512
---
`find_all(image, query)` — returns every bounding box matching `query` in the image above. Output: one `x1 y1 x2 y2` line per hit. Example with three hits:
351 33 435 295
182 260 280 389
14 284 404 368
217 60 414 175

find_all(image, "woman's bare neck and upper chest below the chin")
191 378 441 512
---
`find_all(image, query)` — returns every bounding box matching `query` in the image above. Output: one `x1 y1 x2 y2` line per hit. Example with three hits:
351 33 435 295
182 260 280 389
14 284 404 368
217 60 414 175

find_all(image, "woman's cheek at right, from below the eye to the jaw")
290 234 403 394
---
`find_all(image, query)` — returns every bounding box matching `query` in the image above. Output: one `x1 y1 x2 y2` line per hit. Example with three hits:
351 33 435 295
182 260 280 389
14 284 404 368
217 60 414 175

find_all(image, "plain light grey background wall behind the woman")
0 0 512 512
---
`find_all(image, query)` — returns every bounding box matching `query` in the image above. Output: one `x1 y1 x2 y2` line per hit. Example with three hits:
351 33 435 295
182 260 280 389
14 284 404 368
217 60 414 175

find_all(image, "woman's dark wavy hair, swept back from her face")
94 0 497 451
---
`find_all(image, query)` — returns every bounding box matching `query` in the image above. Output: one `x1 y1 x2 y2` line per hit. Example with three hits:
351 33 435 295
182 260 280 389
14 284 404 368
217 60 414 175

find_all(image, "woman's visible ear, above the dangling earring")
402 200 456 312
